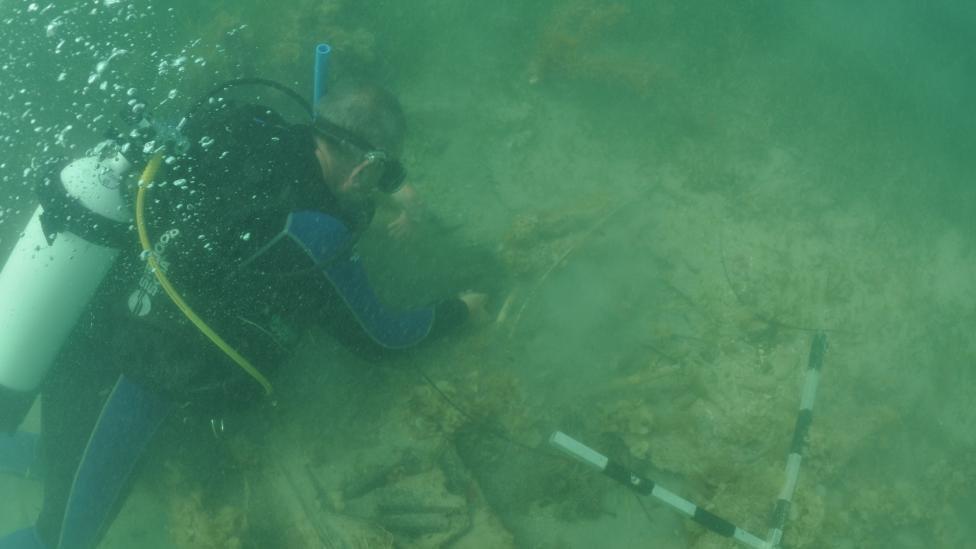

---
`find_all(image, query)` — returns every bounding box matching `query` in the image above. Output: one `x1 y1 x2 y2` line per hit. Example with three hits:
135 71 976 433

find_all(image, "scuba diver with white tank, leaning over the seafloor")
0 76 485 549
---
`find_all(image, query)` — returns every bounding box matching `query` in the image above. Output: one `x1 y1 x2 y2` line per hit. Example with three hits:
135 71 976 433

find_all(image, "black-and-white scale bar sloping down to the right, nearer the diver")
549 431 768 549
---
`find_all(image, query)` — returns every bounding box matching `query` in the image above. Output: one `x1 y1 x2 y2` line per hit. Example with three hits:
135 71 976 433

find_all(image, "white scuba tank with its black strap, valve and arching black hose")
0 79 320 431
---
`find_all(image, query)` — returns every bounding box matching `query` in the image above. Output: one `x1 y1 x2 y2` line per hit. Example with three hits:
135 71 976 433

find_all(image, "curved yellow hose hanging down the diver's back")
136 153 274 395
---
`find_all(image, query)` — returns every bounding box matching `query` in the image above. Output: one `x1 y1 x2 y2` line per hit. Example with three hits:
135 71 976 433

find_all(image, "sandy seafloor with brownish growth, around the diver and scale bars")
0 2 976 549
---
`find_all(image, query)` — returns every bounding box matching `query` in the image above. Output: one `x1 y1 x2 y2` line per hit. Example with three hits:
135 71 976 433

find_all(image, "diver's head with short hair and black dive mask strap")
313 81 406 199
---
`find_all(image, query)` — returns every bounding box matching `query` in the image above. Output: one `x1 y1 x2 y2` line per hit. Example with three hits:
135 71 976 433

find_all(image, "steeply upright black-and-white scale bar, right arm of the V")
766 332 827 548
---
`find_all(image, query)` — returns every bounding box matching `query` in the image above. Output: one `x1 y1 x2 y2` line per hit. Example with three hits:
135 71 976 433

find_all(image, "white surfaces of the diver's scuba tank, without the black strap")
0 154 135 392
